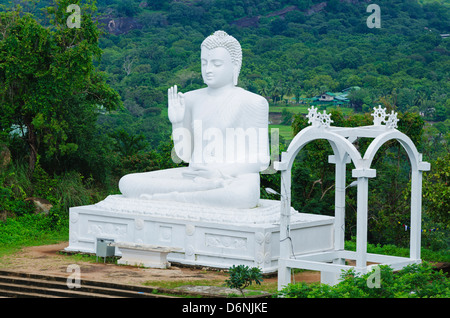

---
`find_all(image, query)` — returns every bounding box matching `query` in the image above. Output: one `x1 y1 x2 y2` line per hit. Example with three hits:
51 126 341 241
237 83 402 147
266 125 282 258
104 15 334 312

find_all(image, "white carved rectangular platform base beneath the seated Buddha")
66 195 334 273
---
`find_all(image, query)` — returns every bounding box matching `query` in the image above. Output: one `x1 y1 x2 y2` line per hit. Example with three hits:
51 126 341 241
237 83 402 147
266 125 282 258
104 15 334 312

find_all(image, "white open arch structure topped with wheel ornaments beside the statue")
274 107 430 290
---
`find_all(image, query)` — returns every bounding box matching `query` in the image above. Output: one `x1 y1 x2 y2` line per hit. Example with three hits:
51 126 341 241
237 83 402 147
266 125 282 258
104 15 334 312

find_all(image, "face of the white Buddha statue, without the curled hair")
201 47 236 88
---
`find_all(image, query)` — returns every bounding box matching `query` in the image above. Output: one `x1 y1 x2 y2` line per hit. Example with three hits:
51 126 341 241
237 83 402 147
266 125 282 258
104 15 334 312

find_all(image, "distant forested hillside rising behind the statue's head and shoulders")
92 0 450 147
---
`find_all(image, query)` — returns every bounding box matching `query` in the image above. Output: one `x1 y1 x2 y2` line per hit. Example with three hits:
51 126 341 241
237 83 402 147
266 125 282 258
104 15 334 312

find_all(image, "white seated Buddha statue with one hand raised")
119 31 270 208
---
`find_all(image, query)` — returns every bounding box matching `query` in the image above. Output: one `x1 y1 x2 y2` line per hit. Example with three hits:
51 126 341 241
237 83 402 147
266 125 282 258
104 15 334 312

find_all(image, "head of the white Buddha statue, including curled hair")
201 31 242 87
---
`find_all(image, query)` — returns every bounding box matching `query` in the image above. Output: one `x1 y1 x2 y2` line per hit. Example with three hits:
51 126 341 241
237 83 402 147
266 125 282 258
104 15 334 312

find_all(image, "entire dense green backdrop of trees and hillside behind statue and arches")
0 0 450 274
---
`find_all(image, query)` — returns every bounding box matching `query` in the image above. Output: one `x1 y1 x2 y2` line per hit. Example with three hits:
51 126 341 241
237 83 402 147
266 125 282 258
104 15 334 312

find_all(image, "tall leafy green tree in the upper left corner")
0 0 121 171
